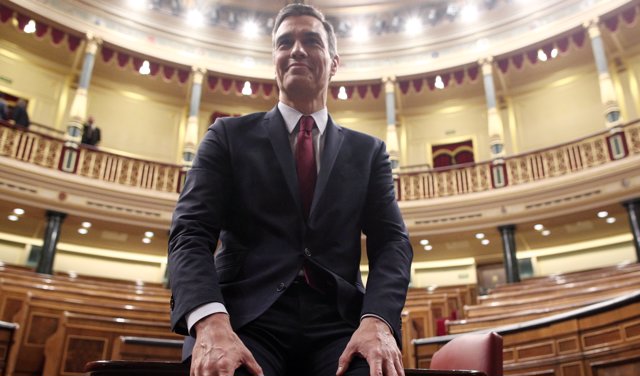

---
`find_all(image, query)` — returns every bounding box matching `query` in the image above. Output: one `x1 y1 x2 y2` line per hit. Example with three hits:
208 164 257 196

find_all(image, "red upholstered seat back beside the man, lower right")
431 332 502 376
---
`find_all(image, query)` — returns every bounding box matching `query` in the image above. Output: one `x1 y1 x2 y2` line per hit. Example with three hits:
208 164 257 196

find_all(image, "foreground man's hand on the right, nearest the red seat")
336 317 404 376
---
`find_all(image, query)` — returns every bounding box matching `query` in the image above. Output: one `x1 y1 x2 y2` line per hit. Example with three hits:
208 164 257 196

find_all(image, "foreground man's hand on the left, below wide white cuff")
191 313 262 376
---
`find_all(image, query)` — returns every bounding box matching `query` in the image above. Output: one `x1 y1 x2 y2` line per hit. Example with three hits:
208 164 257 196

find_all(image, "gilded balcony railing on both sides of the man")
0 120 640 201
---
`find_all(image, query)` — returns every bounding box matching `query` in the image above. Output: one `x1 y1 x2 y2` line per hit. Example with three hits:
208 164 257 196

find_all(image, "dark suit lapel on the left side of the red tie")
263 106 302 210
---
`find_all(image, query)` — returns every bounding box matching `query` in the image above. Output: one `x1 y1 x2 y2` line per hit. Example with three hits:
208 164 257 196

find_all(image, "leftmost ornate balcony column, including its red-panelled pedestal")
59 33 102 173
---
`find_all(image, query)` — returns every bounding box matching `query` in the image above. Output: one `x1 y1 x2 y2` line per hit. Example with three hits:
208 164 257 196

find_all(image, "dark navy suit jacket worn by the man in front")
169 107 413 354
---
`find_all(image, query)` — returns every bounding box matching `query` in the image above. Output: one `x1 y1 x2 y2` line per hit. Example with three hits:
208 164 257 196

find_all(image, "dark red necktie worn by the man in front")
296 116 317 218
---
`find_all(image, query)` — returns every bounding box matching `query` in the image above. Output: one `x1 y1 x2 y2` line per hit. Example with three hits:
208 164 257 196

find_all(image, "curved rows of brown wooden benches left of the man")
0 266 182 376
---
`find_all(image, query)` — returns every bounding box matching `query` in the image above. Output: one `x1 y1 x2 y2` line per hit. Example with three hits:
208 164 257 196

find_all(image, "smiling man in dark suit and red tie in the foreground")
169 4 413 376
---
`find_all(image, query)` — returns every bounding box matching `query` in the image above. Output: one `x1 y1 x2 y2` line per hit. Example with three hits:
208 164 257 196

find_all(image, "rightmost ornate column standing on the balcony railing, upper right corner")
583 19 622 128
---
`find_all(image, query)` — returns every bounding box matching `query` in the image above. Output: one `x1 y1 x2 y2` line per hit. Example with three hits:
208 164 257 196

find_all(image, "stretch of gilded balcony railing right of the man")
394 120 640 201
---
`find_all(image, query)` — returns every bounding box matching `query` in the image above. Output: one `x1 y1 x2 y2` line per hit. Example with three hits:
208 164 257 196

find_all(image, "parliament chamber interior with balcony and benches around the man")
0 0 640 376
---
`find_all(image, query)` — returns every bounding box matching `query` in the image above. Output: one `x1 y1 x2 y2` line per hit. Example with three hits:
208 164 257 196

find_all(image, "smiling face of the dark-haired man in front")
273 16 338 100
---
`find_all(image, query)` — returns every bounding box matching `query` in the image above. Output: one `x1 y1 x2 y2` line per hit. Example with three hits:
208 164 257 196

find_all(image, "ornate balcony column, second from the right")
479 57 504 159
